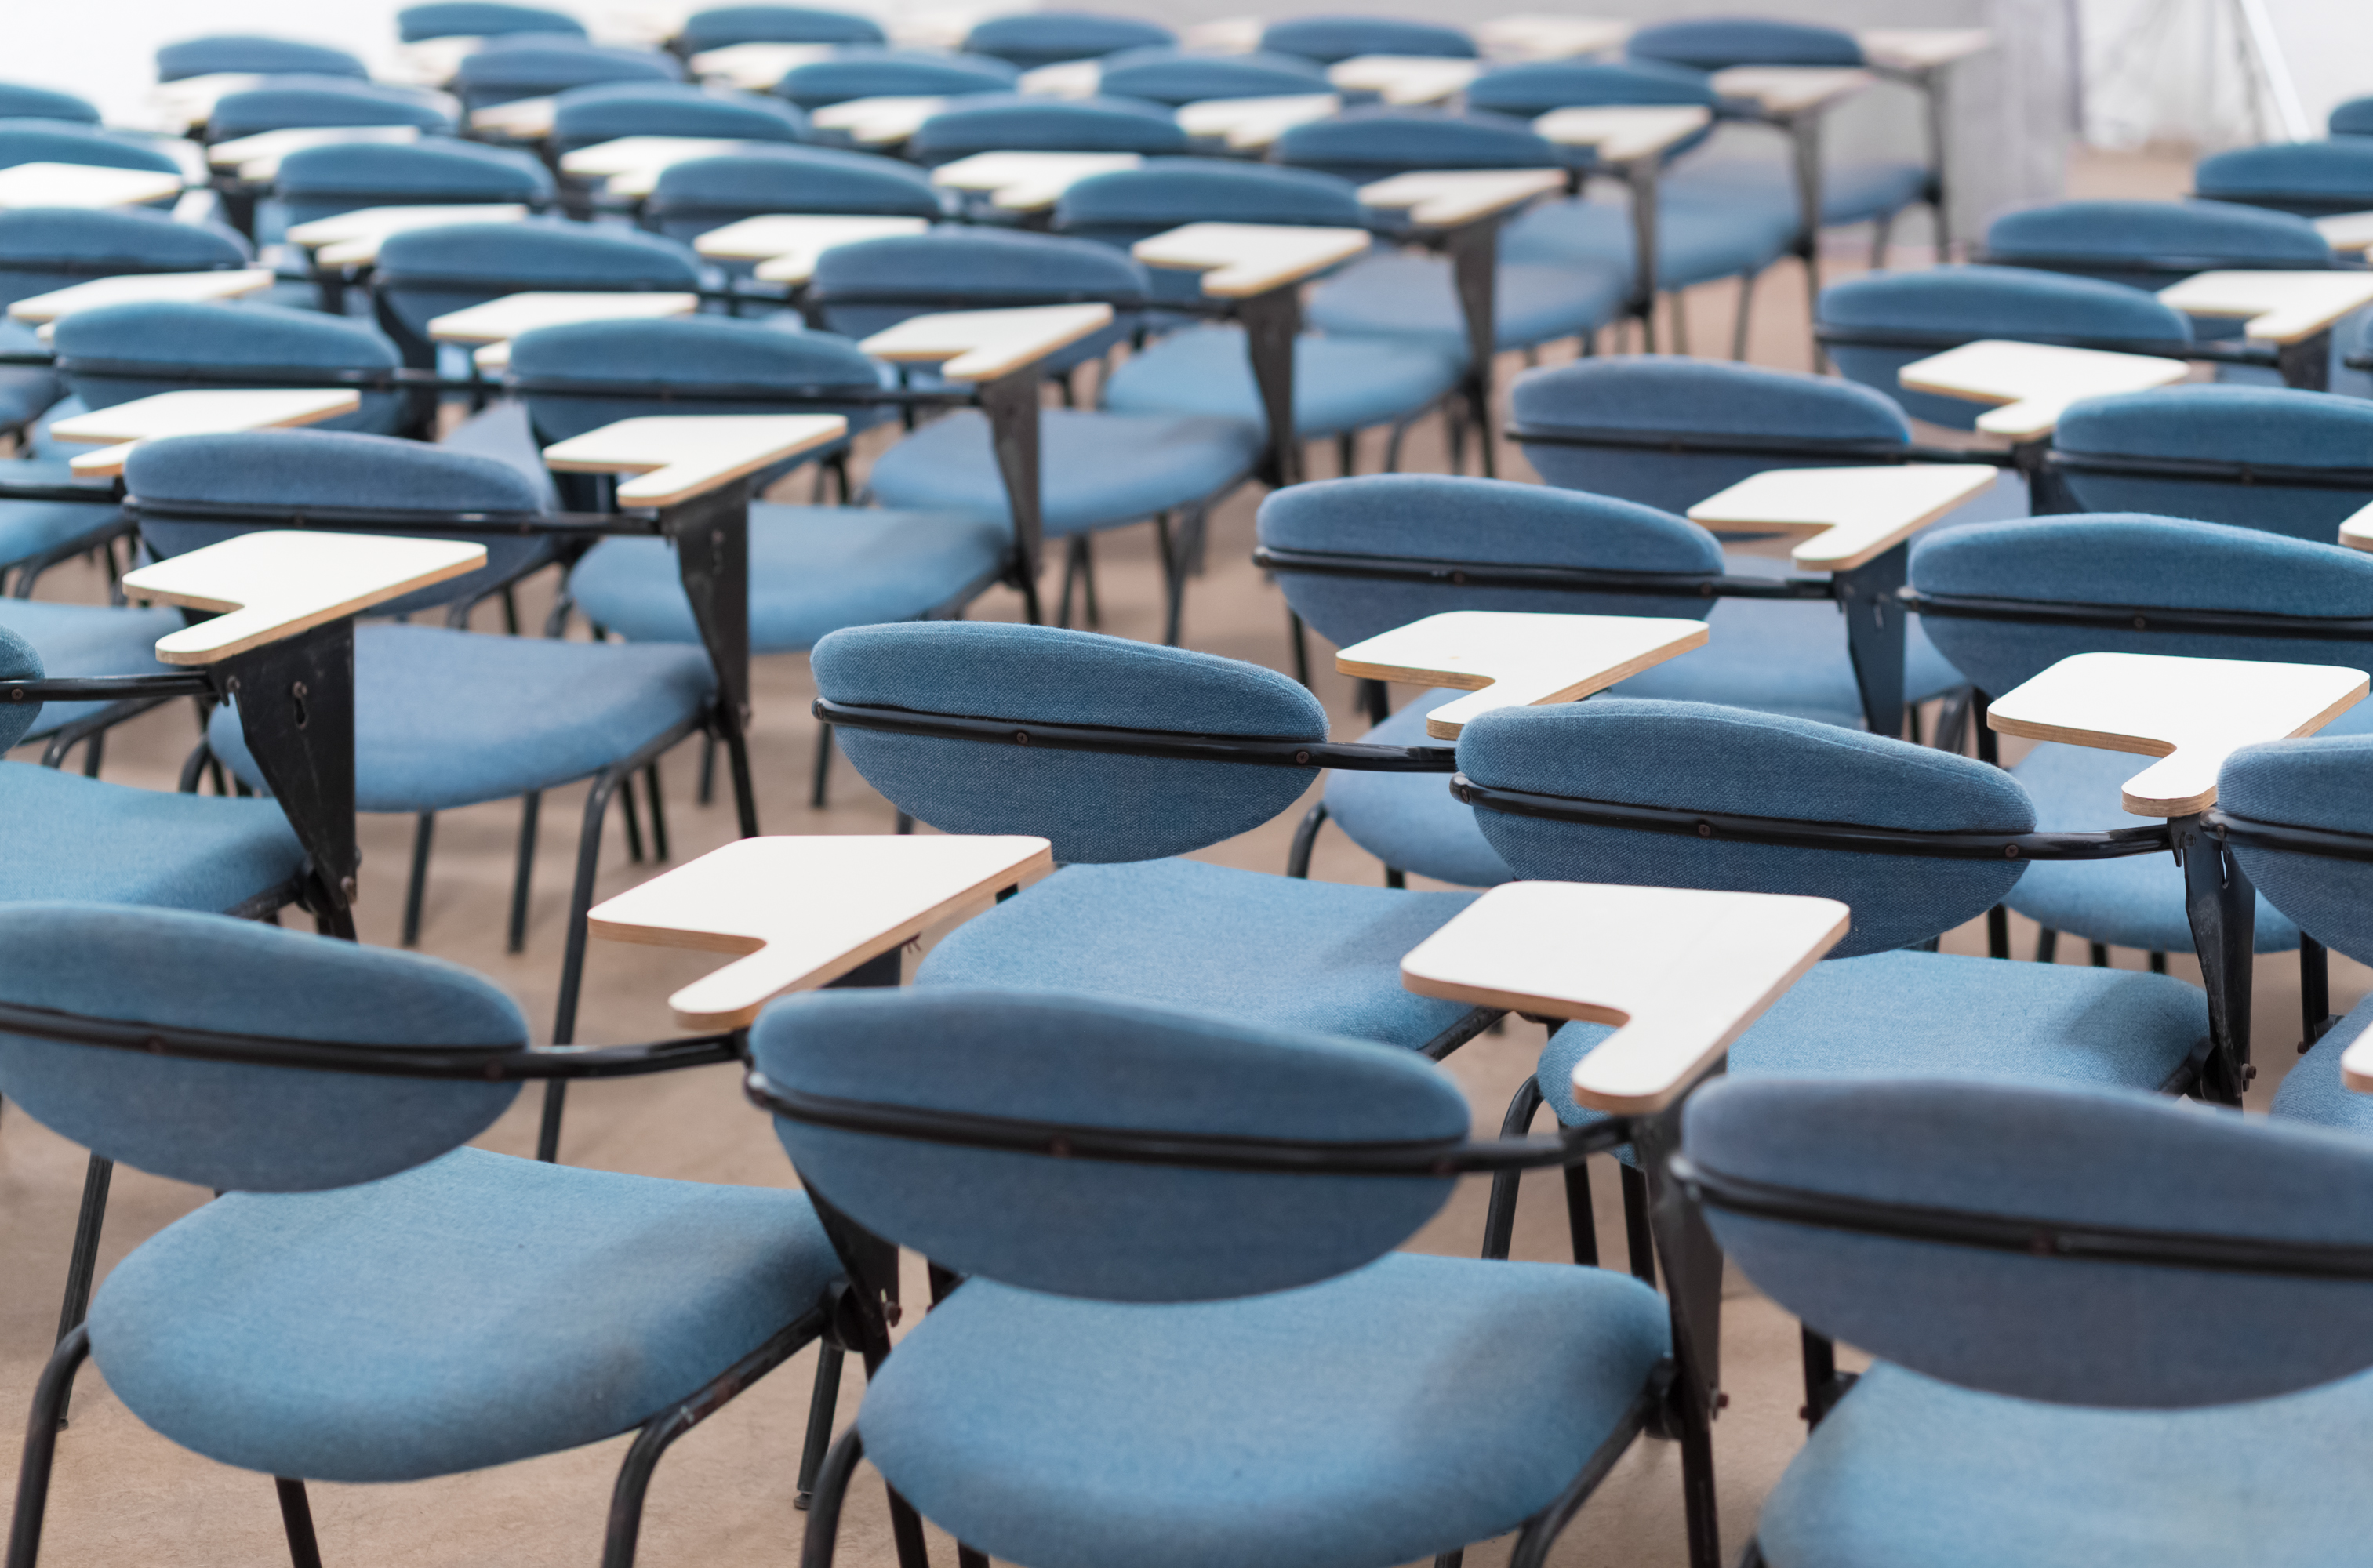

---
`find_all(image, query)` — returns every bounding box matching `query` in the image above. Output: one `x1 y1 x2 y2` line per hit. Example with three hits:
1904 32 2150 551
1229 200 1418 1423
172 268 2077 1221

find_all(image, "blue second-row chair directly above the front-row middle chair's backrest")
809 622 1492 1055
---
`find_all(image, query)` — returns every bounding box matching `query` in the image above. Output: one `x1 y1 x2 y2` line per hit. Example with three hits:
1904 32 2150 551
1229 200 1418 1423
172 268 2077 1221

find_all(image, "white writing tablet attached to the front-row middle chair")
1400 883 1851 1115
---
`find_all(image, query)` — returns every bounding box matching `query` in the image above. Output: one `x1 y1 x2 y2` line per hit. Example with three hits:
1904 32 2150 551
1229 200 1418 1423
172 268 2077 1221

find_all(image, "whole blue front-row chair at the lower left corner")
0 906 840 1568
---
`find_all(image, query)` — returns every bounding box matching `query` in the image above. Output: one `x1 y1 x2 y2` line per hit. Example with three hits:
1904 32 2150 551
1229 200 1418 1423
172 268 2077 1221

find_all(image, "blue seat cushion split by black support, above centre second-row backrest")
866 408 1263 534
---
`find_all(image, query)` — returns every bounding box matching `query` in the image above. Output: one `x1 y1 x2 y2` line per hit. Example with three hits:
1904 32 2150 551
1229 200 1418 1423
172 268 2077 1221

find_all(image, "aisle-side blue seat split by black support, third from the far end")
1305 252 1630 368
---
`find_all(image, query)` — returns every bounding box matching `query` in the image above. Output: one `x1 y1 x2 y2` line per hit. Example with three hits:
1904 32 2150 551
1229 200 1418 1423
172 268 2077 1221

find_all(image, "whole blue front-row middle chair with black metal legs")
750 986 1718 1568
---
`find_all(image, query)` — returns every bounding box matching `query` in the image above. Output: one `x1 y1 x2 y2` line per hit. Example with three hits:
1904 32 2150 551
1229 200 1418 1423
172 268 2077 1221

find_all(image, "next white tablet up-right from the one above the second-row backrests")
1690 463 2003 572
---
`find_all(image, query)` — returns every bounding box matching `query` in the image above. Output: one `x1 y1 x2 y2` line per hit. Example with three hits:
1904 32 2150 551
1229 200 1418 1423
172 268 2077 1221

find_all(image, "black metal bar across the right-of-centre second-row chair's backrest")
1450 773 2174 861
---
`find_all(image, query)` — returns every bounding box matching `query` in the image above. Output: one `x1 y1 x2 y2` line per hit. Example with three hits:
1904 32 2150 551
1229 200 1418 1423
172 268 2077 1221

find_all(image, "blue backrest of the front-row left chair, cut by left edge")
0 896 527 1193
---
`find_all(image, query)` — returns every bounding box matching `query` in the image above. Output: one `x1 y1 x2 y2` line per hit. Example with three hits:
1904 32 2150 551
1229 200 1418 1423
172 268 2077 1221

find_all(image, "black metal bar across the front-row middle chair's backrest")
743 1070 1630 1177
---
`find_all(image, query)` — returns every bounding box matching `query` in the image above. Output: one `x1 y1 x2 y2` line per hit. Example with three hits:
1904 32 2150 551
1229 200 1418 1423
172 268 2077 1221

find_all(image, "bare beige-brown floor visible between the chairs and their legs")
0 157 2366 1568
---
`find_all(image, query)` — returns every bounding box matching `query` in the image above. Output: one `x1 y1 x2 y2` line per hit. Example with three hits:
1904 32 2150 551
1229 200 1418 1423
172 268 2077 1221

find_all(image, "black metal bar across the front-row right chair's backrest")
1670 1156 2373 1279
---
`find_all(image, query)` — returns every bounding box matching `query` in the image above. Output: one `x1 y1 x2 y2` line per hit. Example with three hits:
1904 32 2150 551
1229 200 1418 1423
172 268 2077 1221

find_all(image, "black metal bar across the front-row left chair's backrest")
0 1001 743 1084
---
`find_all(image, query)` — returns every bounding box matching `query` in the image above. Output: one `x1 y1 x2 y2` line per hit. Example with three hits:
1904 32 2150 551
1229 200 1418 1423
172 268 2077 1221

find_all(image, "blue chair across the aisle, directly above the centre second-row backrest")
807 225 1263 641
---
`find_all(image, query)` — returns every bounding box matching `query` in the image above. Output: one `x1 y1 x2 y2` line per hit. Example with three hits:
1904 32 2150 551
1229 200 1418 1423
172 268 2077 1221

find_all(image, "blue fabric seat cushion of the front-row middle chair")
859 1253 1668 1568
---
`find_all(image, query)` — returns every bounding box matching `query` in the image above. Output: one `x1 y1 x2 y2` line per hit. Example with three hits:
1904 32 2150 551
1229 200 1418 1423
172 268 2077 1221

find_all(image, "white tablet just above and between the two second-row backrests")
1336 610 1706 740
